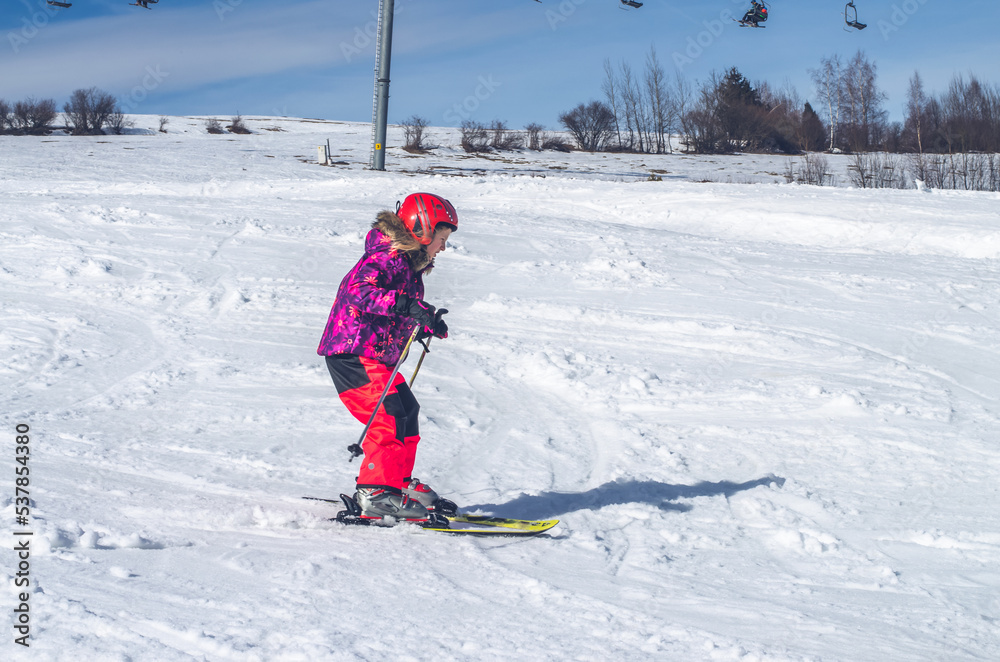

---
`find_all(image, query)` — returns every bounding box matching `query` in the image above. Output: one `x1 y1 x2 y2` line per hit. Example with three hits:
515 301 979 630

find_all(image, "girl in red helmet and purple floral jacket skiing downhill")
317 193 458 521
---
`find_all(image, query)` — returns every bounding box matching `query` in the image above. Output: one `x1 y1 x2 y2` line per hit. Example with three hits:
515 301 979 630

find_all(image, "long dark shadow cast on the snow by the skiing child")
463 475 785 519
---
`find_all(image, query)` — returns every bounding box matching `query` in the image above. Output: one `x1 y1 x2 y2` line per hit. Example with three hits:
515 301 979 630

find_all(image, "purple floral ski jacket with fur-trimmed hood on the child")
316 220 424 365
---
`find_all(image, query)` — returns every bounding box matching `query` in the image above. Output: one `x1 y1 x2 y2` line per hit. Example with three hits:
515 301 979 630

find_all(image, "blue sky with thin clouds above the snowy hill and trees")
0 0 1000 128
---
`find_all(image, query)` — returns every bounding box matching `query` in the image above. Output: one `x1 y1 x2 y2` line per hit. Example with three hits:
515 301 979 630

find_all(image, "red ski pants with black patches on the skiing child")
326 354 420 490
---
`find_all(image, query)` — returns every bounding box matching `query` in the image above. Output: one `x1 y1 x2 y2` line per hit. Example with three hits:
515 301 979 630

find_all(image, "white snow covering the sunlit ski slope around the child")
0 116 1000 662
